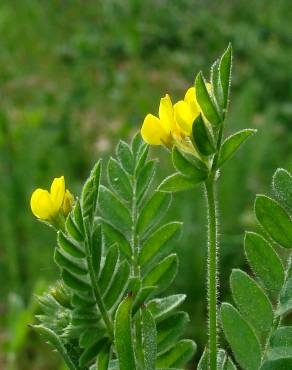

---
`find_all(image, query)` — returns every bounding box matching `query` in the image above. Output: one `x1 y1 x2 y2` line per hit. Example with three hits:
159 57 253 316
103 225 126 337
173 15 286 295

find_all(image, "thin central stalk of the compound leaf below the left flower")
84 237 114 338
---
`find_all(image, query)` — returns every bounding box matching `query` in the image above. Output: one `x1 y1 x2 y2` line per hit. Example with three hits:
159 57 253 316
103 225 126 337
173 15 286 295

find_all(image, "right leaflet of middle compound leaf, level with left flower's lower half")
137 191 172 235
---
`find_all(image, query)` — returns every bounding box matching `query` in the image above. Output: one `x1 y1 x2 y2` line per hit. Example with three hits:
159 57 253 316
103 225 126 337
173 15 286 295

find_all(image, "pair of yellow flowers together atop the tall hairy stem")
141 84 205 148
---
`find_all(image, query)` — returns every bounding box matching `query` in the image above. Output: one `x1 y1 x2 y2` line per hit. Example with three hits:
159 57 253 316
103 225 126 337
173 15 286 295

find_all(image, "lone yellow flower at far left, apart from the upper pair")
30 176 74 221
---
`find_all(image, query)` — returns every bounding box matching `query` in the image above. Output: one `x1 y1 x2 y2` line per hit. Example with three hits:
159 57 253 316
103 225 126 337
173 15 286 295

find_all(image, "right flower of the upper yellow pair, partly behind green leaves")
174 83 211 136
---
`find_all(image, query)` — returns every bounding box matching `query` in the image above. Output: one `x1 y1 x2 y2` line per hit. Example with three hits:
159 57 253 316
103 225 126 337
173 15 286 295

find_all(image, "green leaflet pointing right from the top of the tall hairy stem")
217 128 257 167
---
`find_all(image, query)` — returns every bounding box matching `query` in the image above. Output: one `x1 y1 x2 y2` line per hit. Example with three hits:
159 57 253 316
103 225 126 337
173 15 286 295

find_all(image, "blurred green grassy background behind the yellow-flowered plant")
0 0 292 370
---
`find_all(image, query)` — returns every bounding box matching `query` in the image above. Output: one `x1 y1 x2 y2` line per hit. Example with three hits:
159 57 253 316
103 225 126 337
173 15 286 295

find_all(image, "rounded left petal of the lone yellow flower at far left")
30 189 54 220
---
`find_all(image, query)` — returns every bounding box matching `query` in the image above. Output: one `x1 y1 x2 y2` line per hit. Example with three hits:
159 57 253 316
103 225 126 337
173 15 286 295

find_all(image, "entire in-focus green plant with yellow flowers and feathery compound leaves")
31 46 292 370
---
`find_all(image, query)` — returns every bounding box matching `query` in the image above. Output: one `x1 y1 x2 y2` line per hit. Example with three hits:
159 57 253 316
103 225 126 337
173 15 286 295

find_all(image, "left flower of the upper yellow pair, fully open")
141 94 181 147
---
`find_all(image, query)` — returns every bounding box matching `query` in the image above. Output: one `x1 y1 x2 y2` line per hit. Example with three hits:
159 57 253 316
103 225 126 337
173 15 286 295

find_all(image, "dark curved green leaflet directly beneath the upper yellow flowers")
172 147 207 181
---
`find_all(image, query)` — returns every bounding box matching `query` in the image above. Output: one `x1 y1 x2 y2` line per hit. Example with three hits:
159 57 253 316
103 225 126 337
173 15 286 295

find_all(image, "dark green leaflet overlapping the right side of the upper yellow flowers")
192 114 216 156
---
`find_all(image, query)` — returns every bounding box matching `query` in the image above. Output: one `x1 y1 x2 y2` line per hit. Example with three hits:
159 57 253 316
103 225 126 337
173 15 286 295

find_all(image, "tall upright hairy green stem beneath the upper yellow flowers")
205 173 218 370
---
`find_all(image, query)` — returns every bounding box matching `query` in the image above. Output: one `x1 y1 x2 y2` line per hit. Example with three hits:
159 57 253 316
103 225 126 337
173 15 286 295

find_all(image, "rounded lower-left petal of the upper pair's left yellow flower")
141 114 169 145
